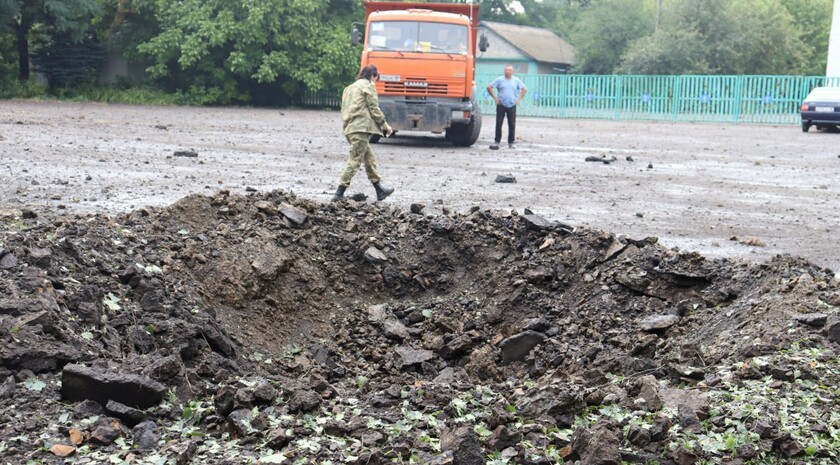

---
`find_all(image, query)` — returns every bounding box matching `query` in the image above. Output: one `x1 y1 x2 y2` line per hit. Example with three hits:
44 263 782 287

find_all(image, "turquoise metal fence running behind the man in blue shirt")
476 74 840 124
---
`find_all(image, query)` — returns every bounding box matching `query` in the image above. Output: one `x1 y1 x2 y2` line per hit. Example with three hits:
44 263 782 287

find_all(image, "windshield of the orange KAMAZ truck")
367 21 467 55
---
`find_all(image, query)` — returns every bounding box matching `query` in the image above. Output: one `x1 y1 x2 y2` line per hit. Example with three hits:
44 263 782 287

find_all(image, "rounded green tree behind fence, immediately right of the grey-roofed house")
567 0 655 74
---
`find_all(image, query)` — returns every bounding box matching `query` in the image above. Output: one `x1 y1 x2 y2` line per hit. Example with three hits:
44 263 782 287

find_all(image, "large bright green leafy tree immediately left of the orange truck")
133 0 363 104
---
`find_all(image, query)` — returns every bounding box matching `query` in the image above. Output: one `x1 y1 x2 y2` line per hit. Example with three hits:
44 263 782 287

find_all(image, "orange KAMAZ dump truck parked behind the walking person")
354 1 486 146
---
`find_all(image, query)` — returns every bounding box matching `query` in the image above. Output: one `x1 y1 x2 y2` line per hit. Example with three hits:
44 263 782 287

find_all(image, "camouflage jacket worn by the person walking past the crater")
341 79 390 136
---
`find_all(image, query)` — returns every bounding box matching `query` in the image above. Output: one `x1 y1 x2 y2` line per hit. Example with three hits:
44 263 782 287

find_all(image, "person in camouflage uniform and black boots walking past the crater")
332 65 394 202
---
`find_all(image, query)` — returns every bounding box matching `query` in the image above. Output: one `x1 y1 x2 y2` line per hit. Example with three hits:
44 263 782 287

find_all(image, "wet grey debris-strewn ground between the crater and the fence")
0 101 840 271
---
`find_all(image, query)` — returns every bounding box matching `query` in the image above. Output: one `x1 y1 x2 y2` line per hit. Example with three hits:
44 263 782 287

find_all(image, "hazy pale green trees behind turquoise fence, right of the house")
553 0 833 75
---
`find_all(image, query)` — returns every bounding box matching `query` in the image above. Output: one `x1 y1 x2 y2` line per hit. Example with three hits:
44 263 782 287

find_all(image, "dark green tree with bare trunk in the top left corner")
0 0 102 81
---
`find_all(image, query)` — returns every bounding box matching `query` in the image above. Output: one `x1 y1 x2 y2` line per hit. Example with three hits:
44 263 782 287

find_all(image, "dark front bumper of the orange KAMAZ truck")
379 96 473 134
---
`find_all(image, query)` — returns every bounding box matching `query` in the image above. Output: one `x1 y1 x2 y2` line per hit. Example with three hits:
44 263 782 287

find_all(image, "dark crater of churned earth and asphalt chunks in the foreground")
0 191 840 465
